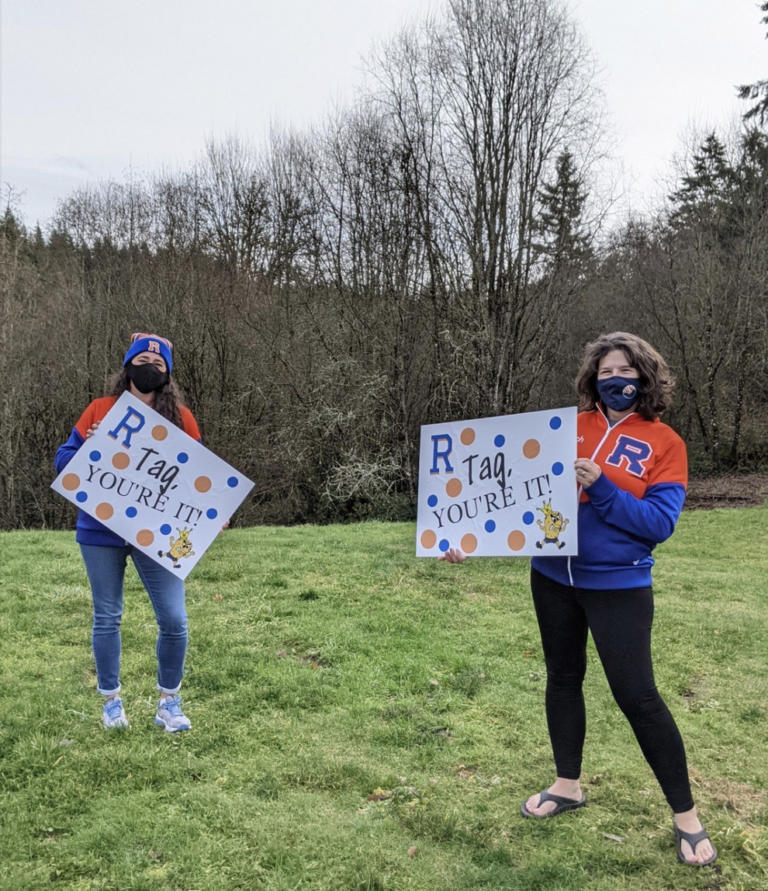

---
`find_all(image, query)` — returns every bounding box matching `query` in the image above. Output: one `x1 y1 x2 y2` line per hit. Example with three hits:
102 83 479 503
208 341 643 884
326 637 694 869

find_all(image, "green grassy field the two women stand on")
0 507 768 891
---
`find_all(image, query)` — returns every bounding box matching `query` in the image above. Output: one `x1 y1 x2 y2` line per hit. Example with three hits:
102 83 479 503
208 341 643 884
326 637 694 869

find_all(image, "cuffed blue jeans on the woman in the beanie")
80 544 187 696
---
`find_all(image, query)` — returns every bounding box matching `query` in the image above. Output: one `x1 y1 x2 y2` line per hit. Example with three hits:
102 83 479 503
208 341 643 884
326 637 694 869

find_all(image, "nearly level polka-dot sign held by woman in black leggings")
416 408 578 557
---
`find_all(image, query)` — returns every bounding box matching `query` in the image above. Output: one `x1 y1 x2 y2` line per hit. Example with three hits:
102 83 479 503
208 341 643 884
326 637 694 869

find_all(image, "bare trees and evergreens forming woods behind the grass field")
0 0 768 529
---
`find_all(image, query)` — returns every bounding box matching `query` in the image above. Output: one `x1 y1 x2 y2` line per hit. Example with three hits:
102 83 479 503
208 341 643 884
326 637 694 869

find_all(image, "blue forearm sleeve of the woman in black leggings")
586 473 685 544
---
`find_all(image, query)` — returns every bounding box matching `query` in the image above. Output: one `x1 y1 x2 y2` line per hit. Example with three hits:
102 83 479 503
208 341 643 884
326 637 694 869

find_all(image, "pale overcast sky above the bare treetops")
0 0 768 224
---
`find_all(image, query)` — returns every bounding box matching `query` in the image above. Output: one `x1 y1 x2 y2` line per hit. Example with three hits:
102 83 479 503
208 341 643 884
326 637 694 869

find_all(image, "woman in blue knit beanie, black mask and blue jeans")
55 333 200 733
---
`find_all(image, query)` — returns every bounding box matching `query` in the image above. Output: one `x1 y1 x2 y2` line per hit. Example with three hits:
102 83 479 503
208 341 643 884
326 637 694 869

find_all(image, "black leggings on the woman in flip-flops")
531 569 693 813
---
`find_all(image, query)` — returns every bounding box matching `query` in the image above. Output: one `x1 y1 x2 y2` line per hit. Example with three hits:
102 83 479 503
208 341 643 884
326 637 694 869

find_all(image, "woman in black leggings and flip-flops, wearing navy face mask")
441 331 717 866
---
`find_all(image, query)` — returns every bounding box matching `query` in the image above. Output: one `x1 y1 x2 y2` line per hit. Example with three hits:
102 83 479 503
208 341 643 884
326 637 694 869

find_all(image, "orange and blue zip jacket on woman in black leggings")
531 408 688 590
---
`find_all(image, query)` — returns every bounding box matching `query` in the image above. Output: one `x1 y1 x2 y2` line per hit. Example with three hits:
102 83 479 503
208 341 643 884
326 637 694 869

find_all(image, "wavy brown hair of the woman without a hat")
574 331 675 421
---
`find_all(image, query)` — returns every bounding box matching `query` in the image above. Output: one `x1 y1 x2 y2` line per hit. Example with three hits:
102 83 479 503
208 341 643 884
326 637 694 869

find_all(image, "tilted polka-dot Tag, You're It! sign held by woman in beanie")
51 392 253 578
